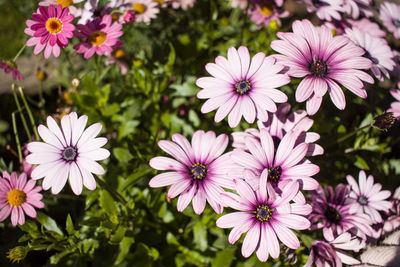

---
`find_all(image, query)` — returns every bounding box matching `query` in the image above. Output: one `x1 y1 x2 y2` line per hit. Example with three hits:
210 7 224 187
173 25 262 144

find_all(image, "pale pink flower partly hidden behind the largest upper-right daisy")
346 29 396 81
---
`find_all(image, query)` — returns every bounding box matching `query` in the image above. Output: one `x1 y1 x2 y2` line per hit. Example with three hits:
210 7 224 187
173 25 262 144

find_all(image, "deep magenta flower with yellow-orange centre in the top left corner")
25 5 75 58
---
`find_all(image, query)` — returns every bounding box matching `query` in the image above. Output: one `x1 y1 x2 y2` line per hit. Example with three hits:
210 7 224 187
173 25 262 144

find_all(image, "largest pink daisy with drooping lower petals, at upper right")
271 20 374 115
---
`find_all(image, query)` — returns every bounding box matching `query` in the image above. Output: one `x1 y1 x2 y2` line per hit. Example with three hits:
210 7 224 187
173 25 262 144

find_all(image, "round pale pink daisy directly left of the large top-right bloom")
196 46 290 128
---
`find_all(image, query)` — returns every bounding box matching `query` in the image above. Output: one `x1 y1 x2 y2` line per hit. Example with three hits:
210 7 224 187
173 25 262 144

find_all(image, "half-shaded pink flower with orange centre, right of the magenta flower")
74 15 122 58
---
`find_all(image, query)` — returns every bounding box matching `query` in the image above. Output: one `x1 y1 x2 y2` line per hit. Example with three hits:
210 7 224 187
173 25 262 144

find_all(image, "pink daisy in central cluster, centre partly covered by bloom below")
229 129 319 193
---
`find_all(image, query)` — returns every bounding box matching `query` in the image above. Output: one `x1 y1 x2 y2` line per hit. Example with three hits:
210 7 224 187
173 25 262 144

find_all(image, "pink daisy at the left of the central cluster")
149 130 234 214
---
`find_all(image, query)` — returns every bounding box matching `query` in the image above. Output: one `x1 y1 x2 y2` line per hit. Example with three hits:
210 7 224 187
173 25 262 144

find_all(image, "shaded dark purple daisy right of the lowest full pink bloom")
309 184 373 241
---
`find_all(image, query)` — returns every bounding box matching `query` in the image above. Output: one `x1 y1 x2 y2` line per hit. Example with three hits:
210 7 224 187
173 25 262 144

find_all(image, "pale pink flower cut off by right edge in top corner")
379 2 400 39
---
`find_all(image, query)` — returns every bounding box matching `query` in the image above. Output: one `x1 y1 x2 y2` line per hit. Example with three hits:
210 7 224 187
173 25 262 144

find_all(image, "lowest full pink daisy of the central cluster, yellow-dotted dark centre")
216 177 310 262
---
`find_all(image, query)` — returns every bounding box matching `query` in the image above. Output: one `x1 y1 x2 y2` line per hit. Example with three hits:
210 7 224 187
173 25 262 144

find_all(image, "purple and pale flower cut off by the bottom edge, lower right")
304 232 365 267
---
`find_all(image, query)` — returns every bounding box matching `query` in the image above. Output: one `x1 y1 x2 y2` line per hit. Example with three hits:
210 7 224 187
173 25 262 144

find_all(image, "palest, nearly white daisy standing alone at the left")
26 112 110 195
